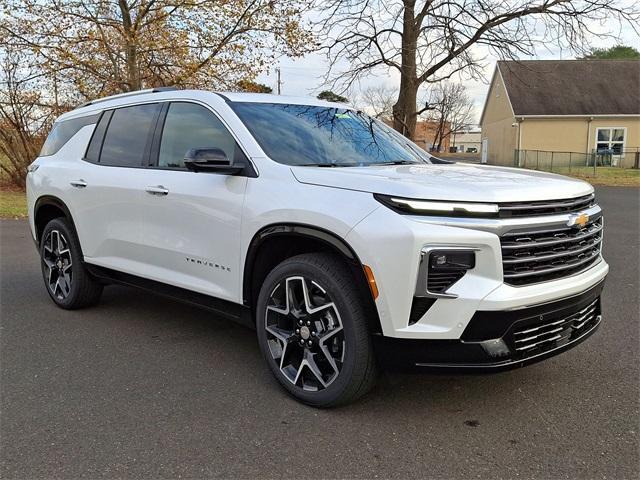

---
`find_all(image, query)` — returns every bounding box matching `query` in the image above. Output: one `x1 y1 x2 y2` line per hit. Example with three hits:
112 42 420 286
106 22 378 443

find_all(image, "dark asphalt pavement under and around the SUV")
0 188 640 479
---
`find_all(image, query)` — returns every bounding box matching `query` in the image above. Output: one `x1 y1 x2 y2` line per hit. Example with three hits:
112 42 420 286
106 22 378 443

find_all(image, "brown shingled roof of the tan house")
497 60 640 116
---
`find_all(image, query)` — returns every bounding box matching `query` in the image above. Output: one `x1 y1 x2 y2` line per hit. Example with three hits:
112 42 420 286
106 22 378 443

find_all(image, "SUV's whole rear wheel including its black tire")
40 217 103 310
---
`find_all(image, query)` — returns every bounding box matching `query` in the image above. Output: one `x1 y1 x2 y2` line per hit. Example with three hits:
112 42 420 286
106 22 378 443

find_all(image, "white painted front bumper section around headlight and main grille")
346 201 609 345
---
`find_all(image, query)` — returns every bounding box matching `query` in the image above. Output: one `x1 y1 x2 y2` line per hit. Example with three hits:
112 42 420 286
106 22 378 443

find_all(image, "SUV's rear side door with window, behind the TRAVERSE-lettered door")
71 103 160 275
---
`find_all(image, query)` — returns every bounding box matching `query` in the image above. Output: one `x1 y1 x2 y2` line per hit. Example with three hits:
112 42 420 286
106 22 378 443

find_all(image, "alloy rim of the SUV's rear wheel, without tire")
42 230 73 300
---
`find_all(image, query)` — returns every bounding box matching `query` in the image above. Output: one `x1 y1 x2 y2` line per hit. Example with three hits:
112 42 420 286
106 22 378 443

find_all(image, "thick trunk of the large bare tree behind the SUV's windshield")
393 0 419 139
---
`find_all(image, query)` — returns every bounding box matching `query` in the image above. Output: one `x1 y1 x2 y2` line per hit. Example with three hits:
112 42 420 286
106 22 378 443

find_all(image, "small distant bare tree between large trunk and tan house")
425 81 474 151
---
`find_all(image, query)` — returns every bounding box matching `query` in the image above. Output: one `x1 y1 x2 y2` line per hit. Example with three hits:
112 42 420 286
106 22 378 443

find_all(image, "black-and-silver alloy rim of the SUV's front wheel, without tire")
265 276 345 391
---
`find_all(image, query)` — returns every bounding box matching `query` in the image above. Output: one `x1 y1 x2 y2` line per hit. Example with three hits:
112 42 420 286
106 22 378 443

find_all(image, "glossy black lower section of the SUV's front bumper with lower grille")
375 281 604 371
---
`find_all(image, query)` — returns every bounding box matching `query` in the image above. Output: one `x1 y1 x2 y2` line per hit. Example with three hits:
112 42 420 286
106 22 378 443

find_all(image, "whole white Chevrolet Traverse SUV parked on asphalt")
27 89 608 406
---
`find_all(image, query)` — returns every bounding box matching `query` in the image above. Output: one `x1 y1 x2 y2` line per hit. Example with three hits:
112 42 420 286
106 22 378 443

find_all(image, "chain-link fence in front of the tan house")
514 148 640 176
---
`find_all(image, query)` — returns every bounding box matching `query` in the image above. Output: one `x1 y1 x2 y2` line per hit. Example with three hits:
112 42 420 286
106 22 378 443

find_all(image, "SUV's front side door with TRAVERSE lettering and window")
136 102 249 301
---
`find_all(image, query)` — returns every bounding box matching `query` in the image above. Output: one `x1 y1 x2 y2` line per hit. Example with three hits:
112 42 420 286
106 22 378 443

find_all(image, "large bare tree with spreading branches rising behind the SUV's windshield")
317 0 640 141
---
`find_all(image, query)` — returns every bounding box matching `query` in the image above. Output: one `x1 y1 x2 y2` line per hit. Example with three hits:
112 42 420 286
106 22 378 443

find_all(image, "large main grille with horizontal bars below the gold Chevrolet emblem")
500 217 603 285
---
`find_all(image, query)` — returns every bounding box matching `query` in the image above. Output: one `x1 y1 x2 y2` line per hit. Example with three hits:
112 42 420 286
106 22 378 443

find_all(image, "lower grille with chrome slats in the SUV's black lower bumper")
511 298 600 357
